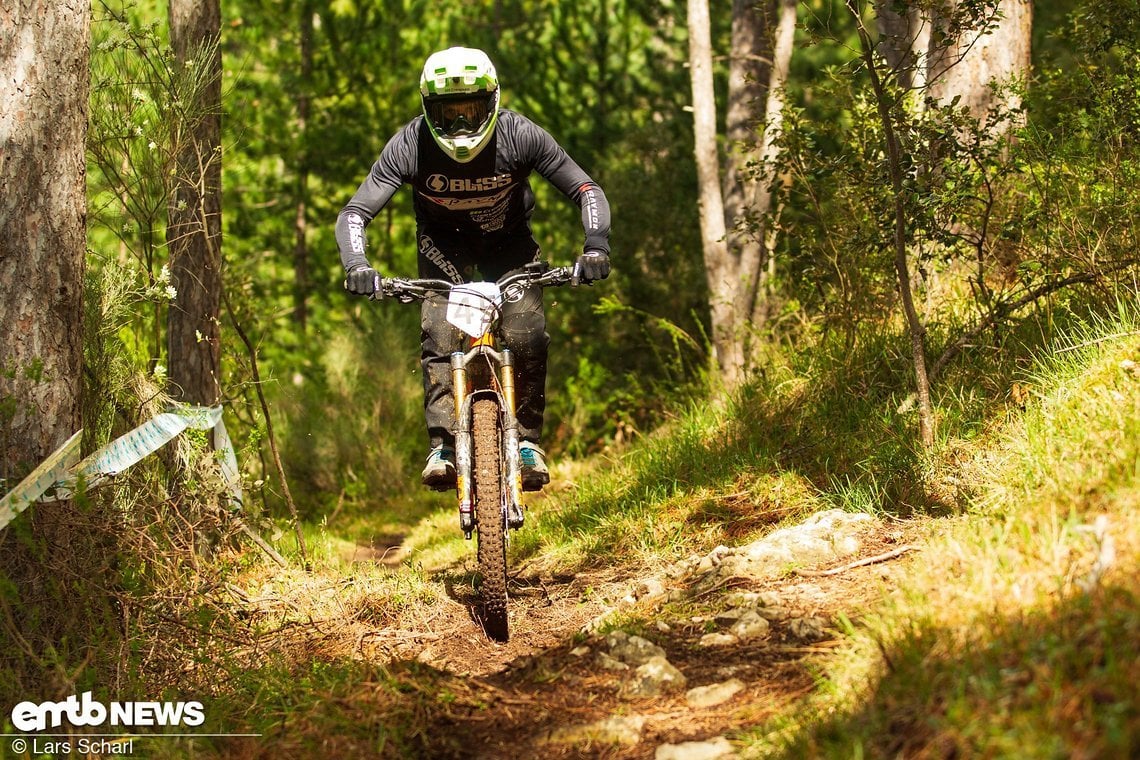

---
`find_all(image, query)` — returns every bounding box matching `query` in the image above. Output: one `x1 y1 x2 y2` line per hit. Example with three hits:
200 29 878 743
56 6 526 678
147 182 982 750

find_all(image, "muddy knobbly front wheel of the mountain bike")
471 399 510 641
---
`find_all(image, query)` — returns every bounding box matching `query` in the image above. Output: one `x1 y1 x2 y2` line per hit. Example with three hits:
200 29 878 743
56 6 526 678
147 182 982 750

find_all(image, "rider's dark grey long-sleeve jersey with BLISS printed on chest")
336 108 610 271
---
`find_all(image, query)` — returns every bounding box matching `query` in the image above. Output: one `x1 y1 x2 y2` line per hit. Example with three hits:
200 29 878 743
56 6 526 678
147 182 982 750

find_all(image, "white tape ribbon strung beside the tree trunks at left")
0 404 242 530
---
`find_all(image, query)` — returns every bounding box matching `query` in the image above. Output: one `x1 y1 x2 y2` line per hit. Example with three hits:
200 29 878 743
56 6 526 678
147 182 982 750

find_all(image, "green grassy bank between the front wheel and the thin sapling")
494 309 1021 571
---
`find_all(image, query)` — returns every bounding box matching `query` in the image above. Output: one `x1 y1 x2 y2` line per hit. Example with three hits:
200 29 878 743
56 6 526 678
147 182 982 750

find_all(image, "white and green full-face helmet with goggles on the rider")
420 48 499 163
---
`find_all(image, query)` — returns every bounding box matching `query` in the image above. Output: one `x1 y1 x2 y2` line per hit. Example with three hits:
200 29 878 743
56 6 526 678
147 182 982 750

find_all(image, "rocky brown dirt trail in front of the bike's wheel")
363 510 917 760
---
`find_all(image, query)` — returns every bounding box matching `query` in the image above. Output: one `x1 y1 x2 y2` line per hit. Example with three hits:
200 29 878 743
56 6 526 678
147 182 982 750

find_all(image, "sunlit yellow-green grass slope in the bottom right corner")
740 305 1140 758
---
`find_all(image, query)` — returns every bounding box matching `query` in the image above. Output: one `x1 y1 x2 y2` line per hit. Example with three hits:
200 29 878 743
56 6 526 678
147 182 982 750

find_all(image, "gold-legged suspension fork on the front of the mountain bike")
451 348 523 540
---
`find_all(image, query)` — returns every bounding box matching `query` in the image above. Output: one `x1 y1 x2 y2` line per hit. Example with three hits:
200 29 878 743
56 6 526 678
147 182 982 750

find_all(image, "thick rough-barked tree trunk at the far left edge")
0 0 91 480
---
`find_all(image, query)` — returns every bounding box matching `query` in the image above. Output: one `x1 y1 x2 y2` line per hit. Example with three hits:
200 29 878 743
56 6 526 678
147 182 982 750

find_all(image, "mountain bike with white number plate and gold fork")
380 261 578 641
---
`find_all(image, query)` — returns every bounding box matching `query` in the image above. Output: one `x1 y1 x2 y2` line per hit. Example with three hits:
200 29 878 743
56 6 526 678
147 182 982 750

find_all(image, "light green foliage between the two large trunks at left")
87 2 223 369
